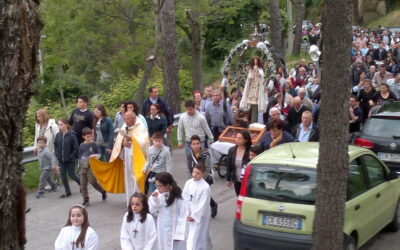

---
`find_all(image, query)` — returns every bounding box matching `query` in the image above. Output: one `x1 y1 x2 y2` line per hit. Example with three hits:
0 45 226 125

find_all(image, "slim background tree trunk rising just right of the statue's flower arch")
268 0 284 55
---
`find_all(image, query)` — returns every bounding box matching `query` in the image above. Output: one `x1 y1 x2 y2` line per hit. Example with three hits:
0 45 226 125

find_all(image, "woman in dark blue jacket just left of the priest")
93 104 114 162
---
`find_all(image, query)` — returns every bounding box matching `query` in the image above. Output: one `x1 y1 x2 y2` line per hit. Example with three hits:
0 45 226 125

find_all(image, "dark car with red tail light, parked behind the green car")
354 101 400 173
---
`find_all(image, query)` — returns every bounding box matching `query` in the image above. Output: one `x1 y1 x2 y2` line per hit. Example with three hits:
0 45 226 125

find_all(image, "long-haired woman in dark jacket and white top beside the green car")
226 130 251 195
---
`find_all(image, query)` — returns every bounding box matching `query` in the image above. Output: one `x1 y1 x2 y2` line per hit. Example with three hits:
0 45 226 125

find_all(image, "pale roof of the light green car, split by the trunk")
250 142 369 168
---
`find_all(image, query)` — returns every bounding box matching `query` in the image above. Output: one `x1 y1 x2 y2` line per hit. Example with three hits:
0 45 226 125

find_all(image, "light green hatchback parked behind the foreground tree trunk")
234 142 400 250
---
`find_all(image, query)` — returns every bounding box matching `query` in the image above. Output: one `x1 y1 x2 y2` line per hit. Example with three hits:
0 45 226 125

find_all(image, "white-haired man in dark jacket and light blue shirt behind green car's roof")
293 110 319 142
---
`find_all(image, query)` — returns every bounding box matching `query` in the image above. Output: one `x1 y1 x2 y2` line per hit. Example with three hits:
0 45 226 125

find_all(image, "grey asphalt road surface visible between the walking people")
26 150 400 250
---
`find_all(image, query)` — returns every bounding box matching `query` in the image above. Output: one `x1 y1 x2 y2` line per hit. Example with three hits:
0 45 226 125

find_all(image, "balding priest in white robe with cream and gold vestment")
110 111 150 205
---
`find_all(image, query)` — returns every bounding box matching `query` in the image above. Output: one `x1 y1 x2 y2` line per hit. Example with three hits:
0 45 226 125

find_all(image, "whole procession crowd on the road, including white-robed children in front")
35 24 400 249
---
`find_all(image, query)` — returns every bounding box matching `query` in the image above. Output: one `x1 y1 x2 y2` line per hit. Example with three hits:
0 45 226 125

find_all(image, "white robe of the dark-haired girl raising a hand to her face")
149 190 188 250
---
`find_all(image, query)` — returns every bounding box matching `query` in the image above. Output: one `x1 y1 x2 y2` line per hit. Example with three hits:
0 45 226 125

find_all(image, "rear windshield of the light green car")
247 165 317 204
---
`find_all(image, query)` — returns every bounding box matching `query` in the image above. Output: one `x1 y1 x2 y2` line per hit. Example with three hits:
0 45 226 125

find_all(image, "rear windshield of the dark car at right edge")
362 118 400 138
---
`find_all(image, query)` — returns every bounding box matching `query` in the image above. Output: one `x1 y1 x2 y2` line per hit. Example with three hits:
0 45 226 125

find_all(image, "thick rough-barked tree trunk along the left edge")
0 0 42 250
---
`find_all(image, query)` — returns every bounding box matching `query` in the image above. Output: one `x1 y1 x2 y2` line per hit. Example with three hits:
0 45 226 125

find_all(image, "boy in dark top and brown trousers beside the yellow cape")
79 128 107 206
